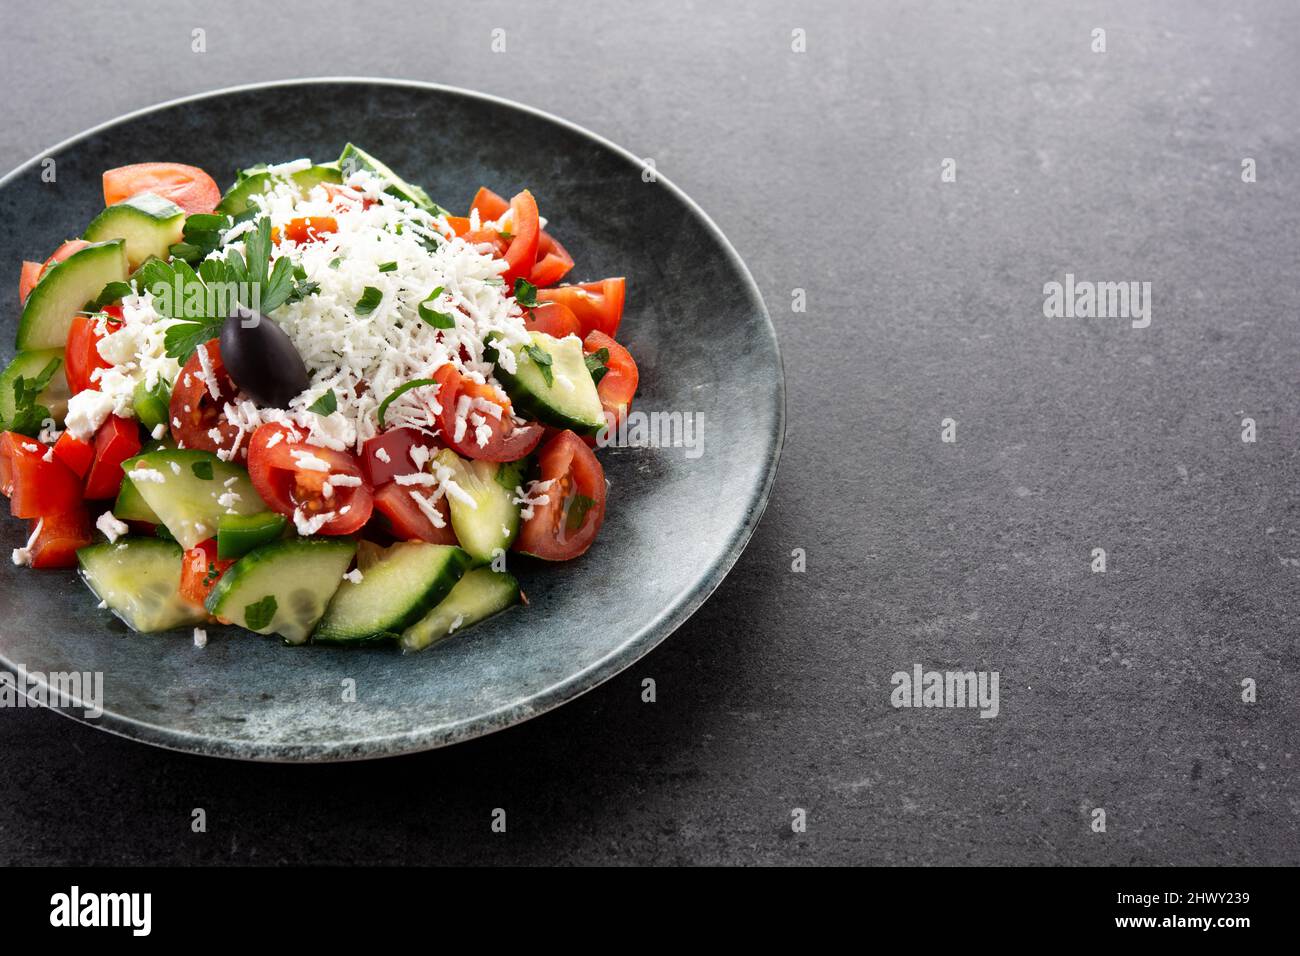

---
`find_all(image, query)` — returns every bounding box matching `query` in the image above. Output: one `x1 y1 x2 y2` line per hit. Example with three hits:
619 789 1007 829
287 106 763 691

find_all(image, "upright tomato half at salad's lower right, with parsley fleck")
512 432 605 561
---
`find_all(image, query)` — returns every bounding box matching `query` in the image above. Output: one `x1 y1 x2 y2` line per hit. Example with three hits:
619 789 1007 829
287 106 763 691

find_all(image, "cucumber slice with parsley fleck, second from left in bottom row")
208 537 356 644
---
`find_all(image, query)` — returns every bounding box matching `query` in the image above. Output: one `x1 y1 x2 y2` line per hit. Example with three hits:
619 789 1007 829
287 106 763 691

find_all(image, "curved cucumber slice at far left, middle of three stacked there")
18 239 129 351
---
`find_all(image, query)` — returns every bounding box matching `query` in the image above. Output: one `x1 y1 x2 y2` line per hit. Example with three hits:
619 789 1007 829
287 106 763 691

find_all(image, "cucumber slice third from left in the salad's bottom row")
312 541 469 644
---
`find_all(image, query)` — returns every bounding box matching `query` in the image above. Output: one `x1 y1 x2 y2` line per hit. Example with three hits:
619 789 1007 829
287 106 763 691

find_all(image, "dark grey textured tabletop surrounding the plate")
0 0 1300 864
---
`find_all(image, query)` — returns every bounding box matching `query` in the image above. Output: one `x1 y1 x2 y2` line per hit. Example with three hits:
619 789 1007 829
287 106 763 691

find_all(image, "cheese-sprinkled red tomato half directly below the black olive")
248 424 374 535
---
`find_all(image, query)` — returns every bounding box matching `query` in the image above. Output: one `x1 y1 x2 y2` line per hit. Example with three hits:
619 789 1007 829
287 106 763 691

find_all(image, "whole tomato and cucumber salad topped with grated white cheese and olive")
0 144 637 650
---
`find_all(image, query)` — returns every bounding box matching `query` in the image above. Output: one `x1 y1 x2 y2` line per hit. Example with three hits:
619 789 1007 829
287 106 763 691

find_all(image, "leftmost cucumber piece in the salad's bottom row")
77 537 208 633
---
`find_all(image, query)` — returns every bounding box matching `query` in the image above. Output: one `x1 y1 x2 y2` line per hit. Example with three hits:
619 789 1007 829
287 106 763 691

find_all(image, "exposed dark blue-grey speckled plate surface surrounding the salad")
0 79 785 761
